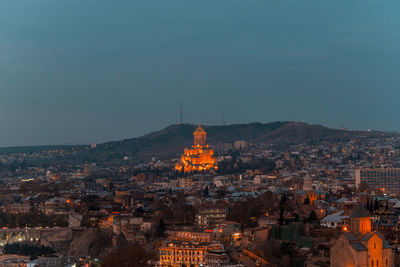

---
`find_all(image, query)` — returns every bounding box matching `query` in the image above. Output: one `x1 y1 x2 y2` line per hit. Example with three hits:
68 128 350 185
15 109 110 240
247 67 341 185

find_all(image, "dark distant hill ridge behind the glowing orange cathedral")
0 122 393 162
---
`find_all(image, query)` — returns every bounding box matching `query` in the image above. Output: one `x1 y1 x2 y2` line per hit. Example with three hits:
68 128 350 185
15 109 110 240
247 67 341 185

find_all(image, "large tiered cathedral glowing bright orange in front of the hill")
175 125 218 172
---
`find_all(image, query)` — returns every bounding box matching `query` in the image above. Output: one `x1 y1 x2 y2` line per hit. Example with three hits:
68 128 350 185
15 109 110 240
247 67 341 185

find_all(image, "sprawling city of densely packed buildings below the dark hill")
0 123 400 267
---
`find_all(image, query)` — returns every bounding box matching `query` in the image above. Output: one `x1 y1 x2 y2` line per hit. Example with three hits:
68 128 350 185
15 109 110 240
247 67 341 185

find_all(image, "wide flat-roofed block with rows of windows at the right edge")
355 168 400 194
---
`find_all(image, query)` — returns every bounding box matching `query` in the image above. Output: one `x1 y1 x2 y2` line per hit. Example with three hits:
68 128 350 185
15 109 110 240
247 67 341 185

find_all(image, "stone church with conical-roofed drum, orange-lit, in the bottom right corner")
330 204 393 267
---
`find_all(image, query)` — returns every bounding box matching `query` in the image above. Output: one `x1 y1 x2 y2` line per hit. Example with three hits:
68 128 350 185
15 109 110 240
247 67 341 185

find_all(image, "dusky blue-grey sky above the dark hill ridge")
0 0 400 146
